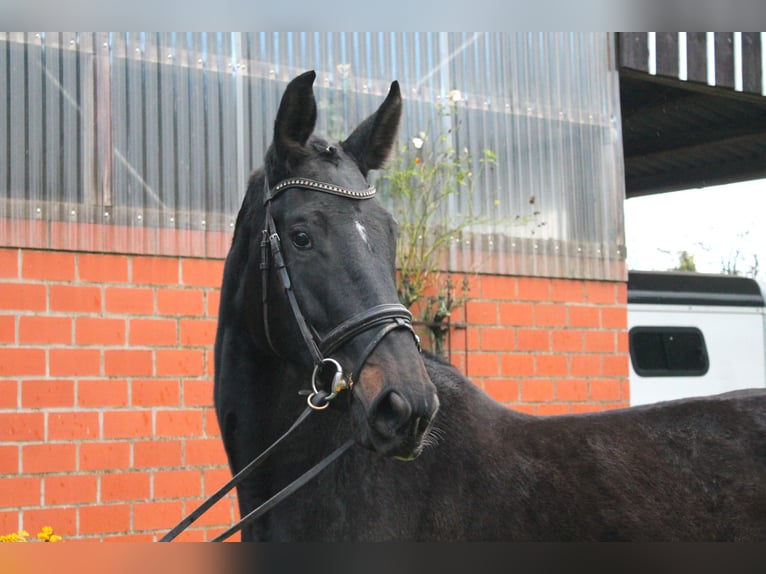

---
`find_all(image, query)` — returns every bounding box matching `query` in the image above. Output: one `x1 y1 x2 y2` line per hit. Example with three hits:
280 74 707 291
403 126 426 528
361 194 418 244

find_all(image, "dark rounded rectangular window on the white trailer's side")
630 327 710 377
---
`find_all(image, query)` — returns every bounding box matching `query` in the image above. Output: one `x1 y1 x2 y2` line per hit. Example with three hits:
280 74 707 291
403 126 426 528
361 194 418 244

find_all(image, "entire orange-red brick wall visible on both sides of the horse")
0 249 628 540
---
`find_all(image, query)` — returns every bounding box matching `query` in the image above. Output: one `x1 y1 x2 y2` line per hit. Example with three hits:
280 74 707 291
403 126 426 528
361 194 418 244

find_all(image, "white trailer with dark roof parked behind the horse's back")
628 271 766 405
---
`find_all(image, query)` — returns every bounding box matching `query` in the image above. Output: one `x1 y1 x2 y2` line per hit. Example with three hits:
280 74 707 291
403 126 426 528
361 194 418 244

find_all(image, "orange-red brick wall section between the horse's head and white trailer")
452 275 629 415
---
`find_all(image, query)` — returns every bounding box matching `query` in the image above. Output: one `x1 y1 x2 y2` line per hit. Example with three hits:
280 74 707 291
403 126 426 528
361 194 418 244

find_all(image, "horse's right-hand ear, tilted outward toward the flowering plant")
341 82 402 175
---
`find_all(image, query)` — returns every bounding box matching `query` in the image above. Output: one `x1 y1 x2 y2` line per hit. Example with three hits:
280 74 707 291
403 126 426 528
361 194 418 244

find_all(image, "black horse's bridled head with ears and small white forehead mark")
240 72 438 459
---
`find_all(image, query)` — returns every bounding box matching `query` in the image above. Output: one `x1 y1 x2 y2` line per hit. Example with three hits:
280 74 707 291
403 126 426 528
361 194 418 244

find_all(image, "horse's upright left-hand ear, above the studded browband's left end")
274 70 317 161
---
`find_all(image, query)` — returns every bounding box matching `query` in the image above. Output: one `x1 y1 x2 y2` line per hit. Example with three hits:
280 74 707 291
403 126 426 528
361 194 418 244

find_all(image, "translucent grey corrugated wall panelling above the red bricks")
0 32 625 280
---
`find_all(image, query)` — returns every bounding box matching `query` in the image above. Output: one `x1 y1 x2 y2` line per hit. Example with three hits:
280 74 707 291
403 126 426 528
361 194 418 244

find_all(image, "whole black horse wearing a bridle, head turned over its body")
215 72 766 541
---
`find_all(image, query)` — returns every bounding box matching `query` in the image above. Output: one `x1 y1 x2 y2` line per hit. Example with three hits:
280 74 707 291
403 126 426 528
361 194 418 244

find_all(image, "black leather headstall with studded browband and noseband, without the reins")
260 175 420 410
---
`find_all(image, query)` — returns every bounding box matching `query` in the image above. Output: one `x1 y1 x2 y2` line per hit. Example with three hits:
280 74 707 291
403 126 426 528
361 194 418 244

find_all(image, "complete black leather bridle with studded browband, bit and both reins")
160 175 421 542
